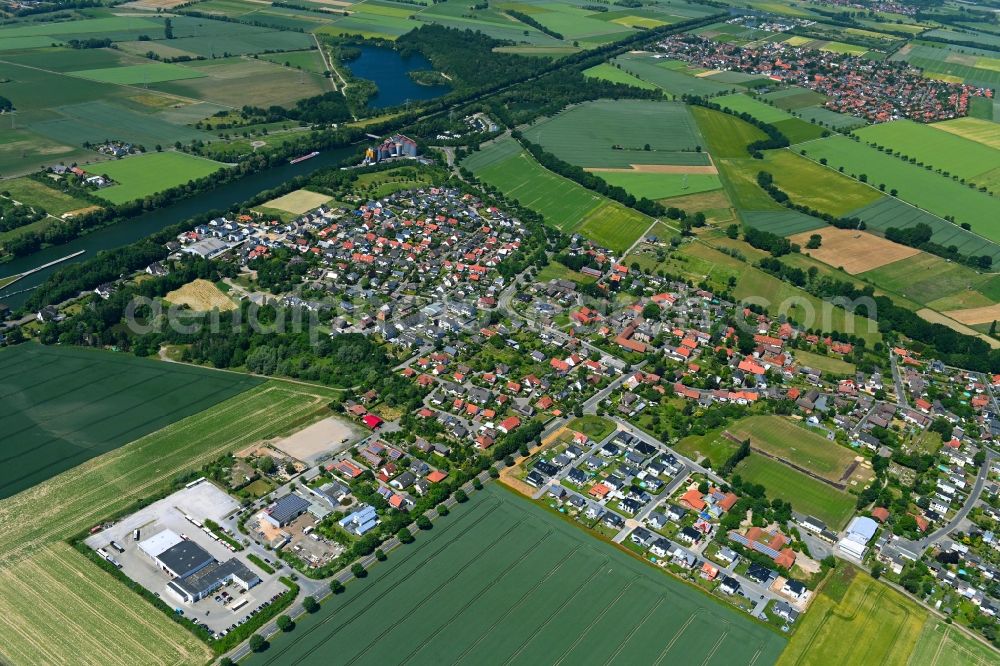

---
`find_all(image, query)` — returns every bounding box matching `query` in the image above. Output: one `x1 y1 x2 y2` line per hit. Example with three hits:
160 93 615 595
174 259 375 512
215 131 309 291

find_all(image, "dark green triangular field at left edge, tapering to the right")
0 345 259 497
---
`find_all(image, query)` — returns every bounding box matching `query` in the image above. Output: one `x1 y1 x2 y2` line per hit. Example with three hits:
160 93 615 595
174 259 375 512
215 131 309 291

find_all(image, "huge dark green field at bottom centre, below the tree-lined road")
247 484 785 665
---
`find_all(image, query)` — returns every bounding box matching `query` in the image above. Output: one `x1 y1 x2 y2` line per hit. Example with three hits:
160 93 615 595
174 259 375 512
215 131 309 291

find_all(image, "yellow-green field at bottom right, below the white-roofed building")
778 563 928 666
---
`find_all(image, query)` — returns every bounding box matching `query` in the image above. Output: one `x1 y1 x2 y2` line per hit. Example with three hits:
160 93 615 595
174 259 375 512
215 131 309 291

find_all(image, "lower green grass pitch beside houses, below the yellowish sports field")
733 453 855 530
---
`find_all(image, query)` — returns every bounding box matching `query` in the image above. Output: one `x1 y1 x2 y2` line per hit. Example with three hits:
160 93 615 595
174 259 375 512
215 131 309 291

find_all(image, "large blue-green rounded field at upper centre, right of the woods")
524 100 709 168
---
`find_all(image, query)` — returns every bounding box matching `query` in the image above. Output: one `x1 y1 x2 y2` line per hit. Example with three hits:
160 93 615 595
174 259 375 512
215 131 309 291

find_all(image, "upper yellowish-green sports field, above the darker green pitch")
728 412 855 482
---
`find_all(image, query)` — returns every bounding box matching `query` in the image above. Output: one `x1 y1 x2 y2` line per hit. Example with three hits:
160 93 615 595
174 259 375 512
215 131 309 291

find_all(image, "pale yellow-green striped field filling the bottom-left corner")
0 542 212 666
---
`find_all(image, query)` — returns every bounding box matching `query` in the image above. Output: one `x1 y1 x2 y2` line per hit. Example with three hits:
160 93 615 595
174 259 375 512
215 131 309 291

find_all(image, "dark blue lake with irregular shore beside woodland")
348 46 451 109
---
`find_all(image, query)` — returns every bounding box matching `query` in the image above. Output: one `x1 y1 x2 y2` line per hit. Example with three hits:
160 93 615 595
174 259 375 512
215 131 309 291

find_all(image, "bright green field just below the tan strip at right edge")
854 120 1000 182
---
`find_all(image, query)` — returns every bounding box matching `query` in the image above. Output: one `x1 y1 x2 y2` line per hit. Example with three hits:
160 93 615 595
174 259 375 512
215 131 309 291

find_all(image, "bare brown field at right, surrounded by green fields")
788 227 920 275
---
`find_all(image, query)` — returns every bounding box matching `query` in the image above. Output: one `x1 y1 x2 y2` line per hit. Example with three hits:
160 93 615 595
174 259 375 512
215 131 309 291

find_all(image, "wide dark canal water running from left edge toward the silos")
0 146 357 309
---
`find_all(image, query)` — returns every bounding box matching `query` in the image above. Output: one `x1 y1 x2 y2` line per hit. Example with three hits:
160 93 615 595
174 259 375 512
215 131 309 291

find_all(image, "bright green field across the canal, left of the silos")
95 151 225 204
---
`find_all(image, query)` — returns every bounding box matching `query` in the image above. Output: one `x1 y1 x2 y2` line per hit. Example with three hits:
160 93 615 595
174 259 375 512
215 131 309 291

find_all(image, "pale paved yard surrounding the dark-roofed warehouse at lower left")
86 481 287 633
